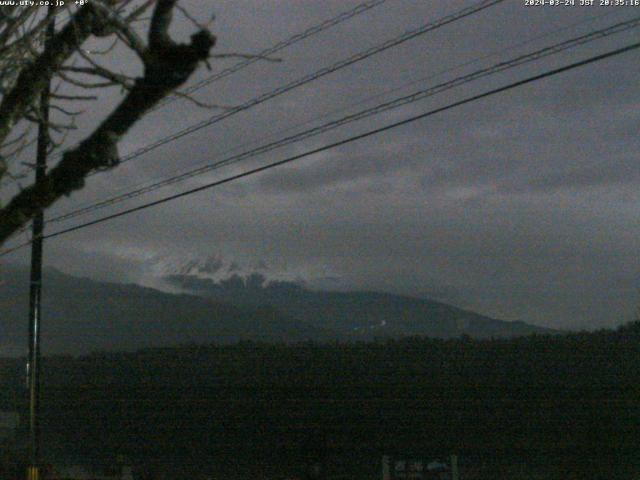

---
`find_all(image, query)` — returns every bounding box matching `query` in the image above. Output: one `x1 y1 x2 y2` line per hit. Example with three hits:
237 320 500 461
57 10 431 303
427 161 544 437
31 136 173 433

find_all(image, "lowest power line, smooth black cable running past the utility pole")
0 42 640 257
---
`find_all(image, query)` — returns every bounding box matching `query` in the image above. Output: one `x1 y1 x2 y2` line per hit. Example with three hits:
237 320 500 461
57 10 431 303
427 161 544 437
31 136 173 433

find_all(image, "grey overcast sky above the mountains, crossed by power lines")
1 0 640 328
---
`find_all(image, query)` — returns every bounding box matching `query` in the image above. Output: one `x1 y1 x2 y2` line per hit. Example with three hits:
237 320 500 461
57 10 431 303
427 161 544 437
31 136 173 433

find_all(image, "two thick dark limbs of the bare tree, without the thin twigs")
0 0 215 244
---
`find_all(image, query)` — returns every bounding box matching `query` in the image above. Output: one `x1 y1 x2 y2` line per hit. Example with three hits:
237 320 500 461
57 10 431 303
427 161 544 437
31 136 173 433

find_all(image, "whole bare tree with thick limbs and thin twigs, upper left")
0 0 215 245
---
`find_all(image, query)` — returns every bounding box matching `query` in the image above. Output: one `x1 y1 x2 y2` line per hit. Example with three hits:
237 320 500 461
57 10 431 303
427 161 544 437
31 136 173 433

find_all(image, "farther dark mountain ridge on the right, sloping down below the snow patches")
165 274 558 340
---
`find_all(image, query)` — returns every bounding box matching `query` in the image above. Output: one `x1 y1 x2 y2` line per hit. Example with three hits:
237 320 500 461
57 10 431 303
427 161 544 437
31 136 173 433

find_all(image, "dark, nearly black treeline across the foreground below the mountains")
0 323 640 479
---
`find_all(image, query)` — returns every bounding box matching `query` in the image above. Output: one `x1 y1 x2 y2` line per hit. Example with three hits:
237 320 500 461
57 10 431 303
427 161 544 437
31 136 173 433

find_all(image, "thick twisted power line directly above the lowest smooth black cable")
49 17 640 226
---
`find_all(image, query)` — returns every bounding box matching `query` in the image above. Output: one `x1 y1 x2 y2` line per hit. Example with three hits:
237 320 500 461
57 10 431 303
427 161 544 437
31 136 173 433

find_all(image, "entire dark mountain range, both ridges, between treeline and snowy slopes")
0 266 552 356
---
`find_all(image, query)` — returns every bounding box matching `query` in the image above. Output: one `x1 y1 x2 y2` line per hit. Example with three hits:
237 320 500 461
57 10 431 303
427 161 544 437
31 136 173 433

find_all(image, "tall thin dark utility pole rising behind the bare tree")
27 7 55 480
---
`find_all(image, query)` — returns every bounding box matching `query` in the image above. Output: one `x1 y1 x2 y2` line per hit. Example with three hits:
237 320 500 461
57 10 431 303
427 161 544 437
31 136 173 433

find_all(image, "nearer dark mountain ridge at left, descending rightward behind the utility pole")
0 265 335 356
